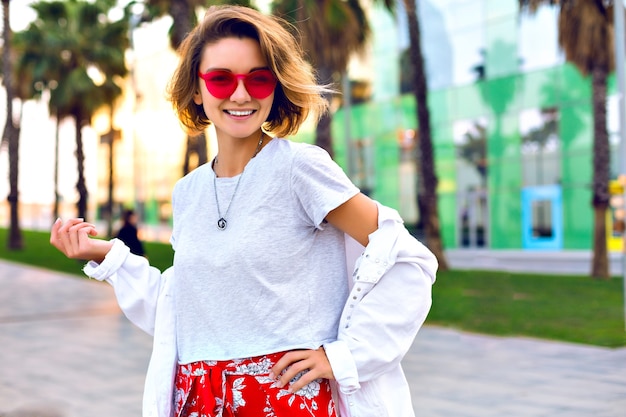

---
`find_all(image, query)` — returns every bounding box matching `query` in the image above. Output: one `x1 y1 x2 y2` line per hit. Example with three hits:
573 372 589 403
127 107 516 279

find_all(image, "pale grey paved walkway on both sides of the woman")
0 261 626 417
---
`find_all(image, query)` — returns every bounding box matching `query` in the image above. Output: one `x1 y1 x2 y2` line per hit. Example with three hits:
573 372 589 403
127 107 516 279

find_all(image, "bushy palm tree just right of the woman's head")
272 0 395 156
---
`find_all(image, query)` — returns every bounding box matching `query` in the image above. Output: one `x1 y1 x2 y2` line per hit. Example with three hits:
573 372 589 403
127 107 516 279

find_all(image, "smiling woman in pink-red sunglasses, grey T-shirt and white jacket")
50 6 437 417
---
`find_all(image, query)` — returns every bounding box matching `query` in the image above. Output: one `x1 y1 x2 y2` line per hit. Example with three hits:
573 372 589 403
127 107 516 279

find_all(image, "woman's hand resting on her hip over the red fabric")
270 347 335 392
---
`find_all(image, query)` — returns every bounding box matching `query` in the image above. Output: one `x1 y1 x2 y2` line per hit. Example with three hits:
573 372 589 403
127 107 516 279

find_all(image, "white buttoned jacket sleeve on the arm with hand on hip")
324 204 438 393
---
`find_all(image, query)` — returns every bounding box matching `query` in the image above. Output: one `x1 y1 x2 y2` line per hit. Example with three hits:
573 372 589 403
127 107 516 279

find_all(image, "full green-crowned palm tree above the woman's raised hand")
19 0 129 218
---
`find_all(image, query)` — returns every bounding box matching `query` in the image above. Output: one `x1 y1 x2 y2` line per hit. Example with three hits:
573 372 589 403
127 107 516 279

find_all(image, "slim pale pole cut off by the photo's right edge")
613 0 626 330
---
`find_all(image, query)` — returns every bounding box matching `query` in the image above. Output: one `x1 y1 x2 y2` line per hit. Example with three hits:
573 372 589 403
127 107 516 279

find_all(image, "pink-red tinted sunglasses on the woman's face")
198 69 277 99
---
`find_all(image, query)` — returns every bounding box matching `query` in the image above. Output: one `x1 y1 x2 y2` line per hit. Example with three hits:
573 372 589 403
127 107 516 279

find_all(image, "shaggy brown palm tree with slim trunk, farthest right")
519 0 623 279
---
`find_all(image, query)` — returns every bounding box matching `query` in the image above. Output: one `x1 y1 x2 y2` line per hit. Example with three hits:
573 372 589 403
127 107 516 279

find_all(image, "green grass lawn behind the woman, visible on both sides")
0 228 626 347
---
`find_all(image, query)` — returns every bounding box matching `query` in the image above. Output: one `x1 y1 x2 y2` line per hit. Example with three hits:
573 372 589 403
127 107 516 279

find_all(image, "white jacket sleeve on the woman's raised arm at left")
83 239 173 335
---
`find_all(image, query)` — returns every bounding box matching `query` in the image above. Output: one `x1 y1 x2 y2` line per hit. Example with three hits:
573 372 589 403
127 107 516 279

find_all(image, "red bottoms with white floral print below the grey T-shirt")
174 353 335 417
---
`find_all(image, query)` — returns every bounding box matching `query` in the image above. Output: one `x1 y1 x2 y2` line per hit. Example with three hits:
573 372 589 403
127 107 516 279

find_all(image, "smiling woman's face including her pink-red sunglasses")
194 38 274 138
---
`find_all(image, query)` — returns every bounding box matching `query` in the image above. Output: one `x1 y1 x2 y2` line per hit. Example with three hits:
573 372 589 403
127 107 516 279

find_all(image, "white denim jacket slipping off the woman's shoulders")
84 204 438 417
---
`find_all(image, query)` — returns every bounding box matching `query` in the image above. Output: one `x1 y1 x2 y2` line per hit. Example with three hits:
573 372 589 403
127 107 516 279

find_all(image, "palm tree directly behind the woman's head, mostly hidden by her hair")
141 0 252 175
